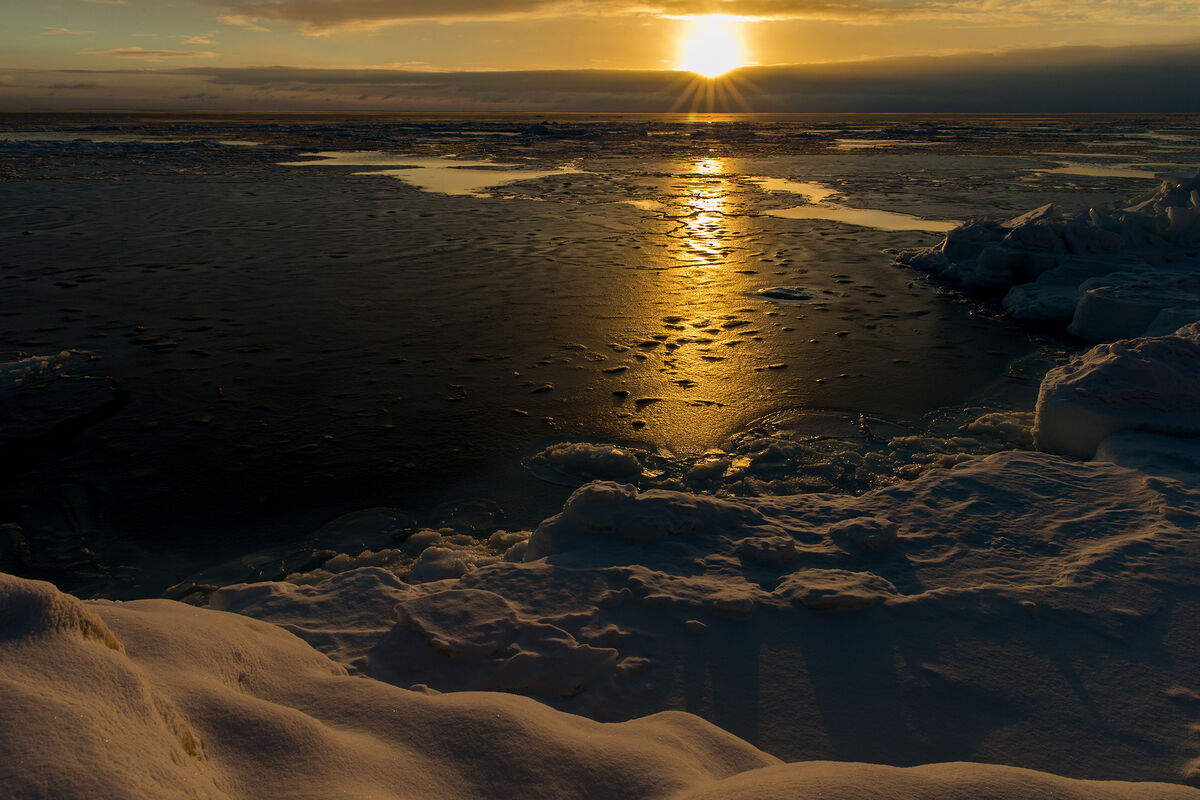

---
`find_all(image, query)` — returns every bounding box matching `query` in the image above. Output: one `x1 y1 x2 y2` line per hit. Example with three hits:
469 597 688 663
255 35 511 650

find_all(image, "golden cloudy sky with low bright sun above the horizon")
0 0 1200 112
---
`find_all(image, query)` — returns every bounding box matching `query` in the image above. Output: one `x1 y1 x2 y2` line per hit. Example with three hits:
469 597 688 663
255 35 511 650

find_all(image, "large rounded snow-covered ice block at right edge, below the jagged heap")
1033 324 1200 458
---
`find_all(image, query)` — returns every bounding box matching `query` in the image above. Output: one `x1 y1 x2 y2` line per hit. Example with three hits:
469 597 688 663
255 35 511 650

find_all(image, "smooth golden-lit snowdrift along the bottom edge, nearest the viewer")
0 576 1200 800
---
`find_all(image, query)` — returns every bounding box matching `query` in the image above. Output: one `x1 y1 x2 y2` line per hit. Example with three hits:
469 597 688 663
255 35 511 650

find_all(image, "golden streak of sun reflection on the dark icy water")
622 157 782 452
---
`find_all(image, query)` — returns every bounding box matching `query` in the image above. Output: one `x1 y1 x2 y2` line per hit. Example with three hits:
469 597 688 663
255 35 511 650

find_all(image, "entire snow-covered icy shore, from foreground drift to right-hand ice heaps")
7 136 1200 799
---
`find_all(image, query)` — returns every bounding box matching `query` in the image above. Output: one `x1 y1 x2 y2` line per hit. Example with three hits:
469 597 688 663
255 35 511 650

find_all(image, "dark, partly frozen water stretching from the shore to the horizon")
0 115 1200 596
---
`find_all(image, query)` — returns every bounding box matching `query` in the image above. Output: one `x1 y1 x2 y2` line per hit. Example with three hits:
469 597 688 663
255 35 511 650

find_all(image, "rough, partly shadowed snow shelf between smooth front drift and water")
211 448 1200 782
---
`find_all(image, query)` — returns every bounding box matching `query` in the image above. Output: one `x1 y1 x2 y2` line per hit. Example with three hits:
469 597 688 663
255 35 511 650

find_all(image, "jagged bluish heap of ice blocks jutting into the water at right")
899 174 1200 342
